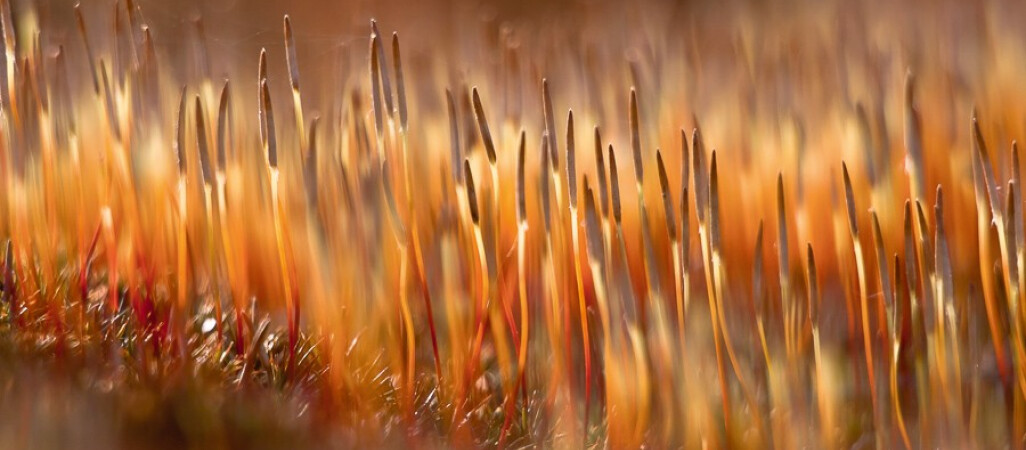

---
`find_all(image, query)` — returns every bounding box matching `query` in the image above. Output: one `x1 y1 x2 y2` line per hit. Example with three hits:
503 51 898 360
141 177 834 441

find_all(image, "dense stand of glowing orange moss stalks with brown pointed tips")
0 0 1026 448
